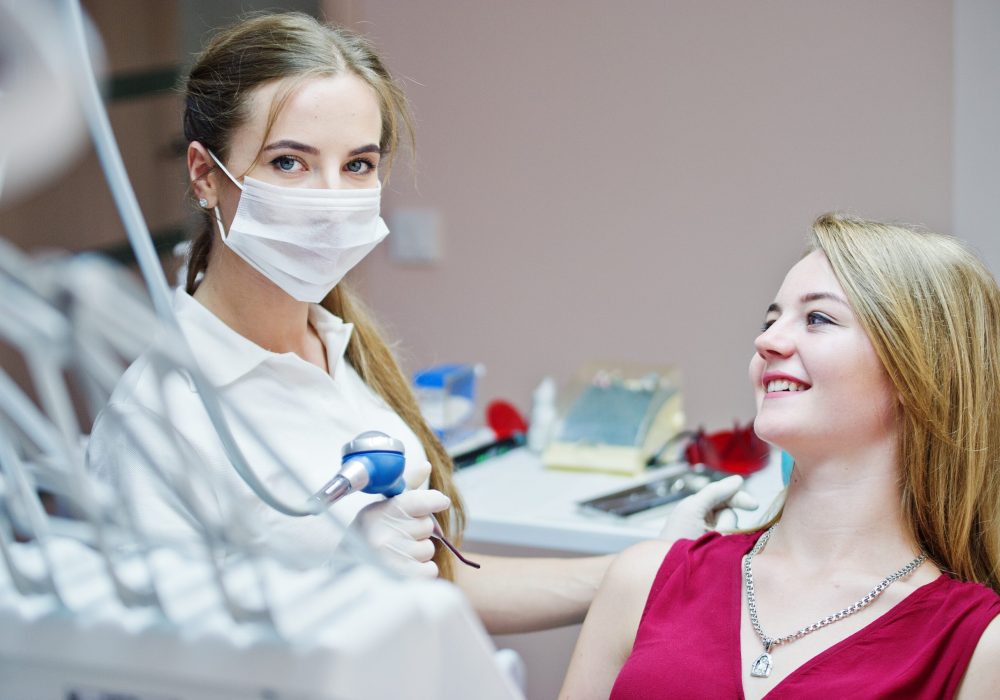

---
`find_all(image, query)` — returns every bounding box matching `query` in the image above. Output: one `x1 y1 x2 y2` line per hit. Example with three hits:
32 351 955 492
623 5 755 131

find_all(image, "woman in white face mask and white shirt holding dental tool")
88 14 742 633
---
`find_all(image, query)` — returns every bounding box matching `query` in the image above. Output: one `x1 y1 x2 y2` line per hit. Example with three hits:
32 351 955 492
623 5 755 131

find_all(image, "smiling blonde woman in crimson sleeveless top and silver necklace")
560 214 1000 699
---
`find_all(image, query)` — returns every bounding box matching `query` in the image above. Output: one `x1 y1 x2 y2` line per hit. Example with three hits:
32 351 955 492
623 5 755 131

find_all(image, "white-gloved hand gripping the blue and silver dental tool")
352 463 451 578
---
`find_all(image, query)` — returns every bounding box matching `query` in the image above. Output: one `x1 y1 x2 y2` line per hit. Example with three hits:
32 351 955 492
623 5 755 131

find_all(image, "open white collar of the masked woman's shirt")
174 288 354 386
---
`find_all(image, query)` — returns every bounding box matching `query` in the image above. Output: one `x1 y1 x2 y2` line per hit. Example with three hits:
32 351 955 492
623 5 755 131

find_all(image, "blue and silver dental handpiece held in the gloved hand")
312 430 480 569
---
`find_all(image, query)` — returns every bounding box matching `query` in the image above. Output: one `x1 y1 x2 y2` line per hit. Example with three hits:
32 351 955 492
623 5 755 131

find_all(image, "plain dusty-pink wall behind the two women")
326 0 952 428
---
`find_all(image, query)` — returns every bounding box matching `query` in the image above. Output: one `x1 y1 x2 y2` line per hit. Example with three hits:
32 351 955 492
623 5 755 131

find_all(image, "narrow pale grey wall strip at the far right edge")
953 0 1000 276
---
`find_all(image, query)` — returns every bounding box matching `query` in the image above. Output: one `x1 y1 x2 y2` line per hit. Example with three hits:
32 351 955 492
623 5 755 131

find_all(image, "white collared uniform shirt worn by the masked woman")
87 289 427 566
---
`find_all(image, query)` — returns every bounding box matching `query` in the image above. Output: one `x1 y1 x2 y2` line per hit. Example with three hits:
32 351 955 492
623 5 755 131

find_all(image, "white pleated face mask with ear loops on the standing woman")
209 152 389 303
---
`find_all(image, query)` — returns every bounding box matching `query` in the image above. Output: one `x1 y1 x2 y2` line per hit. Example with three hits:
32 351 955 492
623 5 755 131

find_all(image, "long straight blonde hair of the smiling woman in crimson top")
813 214 1000 592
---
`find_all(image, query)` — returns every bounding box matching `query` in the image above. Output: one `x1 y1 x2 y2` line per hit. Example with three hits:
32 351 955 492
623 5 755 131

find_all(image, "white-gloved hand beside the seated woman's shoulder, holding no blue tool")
660 474 757 541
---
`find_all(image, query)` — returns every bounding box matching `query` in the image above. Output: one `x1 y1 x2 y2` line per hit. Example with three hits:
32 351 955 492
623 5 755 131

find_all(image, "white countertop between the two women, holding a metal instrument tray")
455 448 781 554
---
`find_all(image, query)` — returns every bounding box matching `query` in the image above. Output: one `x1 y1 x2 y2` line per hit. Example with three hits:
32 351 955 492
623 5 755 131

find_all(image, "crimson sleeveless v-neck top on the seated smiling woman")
610 532 1000 700
